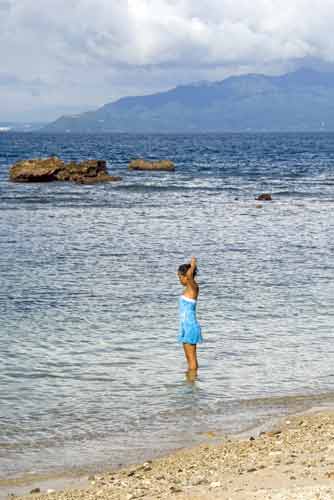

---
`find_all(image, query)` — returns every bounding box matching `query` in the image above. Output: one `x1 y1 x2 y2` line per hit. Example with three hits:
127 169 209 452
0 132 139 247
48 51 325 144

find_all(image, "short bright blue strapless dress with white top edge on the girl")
178 295 203 344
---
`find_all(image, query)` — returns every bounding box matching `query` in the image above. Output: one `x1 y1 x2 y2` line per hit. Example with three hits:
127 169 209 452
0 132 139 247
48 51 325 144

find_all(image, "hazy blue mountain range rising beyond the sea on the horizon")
42 69 334 133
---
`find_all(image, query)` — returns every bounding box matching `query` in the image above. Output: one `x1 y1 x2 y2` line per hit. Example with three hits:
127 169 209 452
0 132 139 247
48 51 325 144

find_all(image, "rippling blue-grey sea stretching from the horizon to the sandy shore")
0 134 334 479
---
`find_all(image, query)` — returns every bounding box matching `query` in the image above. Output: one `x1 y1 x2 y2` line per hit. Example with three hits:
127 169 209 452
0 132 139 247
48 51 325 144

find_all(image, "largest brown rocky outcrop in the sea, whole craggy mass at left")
9 157 121 184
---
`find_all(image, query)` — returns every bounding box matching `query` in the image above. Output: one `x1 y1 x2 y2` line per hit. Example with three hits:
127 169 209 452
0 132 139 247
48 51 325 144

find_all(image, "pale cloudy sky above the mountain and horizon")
0 0 334 121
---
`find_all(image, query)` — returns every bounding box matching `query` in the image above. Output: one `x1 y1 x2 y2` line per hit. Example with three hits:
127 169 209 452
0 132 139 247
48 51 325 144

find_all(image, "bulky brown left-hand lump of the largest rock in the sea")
9 156 65 182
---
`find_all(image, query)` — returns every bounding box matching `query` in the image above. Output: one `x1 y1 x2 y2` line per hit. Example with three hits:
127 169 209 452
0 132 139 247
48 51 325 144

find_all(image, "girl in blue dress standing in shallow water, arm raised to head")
177 257 203 373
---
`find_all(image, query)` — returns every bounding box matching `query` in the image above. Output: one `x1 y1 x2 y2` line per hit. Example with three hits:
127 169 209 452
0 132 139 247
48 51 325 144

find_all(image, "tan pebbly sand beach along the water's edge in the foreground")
4 411 334 500
